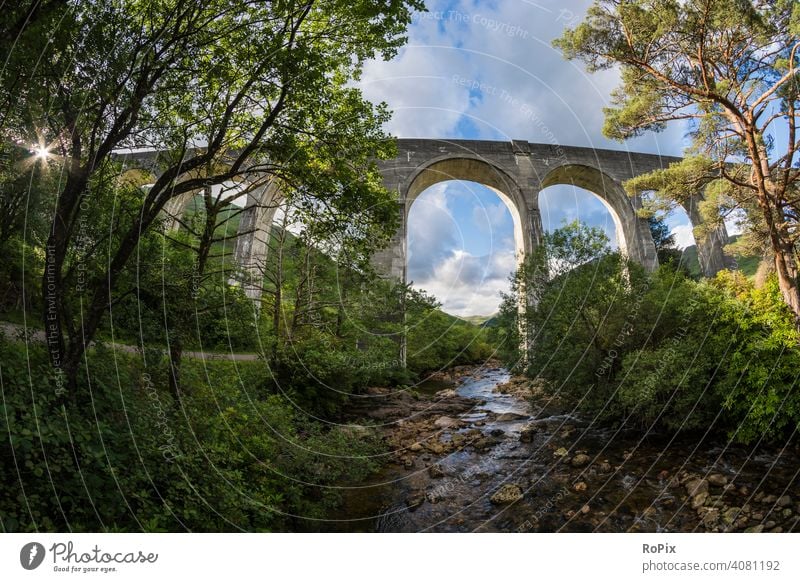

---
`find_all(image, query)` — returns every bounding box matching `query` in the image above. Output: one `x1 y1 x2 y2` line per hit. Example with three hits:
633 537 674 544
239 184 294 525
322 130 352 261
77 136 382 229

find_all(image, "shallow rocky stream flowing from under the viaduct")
321 368 800 532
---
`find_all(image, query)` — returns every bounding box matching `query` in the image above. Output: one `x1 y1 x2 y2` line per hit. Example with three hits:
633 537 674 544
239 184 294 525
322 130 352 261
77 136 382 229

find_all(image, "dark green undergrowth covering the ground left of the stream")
0 340 381 532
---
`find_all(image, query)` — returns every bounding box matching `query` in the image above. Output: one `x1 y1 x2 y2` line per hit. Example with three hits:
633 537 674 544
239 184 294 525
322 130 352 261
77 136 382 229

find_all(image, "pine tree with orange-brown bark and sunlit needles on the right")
554 0 800 323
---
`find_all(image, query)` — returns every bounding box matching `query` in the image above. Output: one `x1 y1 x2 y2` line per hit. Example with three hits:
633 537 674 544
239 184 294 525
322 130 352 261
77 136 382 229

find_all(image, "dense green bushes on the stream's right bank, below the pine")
502 225 800 443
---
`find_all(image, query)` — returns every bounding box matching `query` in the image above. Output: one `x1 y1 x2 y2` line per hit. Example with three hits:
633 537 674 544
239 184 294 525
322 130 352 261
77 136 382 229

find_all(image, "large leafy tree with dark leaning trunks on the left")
0 0 421 396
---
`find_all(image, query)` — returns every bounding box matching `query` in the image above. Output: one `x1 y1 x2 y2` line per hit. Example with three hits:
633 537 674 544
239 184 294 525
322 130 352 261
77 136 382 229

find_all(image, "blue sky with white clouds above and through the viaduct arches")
359 0 693 315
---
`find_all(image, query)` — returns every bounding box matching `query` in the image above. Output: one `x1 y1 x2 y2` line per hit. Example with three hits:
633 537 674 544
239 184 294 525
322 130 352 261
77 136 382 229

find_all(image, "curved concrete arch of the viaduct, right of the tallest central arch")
541 163 658 270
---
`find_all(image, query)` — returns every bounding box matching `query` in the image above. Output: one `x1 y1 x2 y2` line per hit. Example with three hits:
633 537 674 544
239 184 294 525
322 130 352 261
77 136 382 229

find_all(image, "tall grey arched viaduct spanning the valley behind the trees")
124 139 727 299
